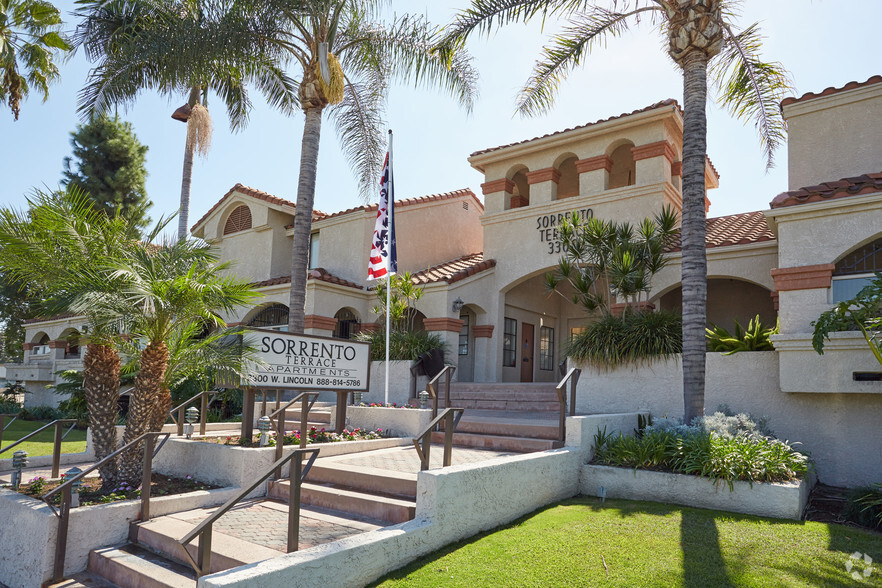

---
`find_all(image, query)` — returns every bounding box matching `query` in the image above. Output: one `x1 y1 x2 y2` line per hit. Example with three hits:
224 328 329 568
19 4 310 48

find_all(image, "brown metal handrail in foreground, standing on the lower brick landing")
178 447 319 578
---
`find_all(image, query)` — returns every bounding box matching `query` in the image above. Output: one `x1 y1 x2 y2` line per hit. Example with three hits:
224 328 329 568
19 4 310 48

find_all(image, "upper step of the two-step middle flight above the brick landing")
306 460 417 500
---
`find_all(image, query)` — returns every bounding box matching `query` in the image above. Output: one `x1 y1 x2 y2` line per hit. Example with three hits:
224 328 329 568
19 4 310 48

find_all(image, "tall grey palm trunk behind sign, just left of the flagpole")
288 106 323 334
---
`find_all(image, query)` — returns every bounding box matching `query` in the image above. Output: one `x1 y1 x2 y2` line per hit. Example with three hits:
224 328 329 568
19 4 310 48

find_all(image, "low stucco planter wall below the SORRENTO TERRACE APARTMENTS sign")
153 437 411 497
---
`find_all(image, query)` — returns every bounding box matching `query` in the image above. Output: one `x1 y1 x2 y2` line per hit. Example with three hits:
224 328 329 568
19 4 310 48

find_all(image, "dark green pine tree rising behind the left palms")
62 116 152 228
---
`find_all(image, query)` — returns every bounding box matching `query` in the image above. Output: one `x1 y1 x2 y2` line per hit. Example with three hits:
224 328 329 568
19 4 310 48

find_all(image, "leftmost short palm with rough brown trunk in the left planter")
0 187 160 488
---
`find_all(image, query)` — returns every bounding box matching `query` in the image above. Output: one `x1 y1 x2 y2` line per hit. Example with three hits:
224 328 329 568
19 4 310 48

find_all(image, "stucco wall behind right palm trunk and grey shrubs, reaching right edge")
570 351 882 487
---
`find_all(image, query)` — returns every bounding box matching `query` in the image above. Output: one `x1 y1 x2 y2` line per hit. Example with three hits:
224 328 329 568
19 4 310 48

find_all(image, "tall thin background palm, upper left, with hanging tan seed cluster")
74 0 297 239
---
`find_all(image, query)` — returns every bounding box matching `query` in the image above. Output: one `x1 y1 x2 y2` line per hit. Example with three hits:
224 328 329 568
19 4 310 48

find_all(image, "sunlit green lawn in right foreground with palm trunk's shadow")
373 490 882 588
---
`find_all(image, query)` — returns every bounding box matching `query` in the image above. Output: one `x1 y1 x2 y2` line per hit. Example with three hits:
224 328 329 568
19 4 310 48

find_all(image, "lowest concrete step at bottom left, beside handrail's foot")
88 545 196 588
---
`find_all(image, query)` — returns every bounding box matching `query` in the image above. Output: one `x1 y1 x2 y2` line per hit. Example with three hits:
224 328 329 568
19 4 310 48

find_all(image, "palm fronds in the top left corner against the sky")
0 0 71 120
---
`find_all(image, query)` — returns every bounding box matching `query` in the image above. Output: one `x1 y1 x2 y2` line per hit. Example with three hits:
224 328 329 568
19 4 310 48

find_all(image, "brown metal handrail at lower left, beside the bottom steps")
41 433 171 582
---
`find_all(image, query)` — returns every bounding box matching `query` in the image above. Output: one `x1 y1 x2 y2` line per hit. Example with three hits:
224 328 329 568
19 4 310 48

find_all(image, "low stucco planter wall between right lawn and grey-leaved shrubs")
579 465 811 520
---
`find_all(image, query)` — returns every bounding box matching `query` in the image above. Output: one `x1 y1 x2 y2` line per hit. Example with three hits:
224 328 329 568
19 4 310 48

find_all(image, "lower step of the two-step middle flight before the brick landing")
268 480 416 524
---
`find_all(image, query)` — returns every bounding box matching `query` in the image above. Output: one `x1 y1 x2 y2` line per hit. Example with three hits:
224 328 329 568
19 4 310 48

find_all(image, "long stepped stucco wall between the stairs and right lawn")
198 413 637 588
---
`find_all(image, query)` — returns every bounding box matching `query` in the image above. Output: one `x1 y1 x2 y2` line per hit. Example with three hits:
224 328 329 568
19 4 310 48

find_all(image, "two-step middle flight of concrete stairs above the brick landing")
268 460 417 524
